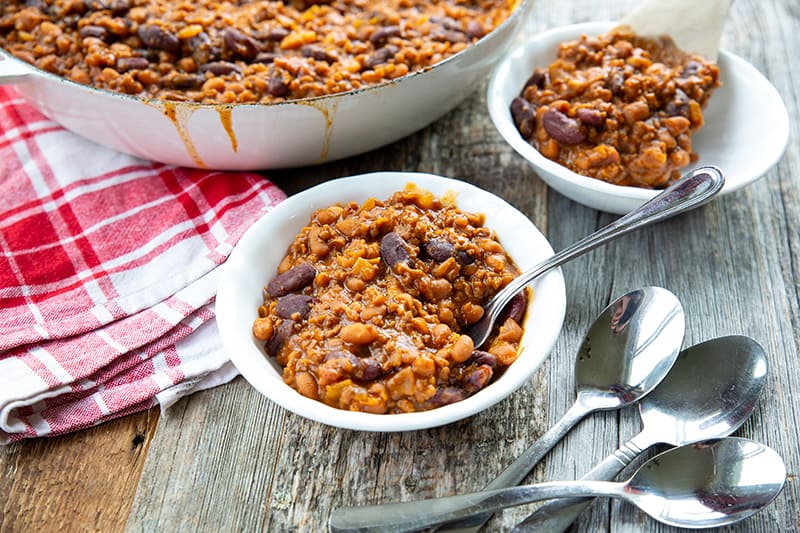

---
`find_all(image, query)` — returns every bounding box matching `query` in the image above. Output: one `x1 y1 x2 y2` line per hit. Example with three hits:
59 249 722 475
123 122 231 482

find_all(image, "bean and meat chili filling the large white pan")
0 0 516 104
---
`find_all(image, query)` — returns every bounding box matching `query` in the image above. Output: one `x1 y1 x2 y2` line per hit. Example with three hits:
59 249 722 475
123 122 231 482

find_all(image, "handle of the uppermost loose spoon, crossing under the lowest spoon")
437 401 589 533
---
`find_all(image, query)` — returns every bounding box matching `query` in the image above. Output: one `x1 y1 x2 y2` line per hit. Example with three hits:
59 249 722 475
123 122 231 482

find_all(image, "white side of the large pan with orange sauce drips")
0 0 533 170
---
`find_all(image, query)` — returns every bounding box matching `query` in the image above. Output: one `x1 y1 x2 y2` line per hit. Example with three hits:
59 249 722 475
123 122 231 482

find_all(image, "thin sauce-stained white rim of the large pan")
0 0 534 109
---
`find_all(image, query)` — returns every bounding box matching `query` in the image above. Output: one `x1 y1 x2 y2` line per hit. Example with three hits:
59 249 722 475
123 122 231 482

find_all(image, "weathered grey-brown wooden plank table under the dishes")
0 0 800 532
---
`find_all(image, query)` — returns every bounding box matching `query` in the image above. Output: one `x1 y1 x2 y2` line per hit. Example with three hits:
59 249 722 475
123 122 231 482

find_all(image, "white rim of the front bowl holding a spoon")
216 172 566 432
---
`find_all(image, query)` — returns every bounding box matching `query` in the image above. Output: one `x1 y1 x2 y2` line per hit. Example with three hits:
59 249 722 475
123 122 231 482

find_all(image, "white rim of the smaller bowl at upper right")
486 21 789 202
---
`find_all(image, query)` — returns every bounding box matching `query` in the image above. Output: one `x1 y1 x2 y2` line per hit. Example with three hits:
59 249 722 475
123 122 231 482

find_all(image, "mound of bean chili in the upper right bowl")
511 28 720 189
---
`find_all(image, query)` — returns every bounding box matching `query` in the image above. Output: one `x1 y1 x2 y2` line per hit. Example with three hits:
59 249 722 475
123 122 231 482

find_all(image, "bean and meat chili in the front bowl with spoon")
253 187 527 413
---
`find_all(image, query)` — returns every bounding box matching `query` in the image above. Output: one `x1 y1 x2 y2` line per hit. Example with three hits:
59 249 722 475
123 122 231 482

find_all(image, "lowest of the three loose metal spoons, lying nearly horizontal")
329 437 786 532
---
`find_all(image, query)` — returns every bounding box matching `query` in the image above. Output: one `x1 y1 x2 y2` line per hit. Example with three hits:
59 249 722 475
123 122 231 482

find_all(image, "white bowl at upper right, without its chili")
487 22 789 214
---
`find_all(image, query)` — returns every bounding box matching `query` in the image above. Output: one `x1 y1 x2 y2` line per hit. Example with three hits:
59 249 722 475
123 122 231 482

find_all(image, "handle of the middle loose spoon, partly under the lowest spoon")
512 433 652 533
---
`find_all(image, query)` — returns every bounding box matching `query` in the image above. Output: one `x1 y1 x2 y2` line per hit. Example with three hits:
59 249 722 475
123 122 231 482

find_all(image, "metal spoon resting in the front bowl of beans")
467 166 725 346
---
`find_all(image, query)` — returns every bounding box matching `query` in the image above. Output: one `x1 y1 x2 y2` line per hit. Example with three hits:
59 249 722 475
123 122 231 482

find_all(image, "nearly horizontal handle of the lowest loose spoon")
328 481 625 533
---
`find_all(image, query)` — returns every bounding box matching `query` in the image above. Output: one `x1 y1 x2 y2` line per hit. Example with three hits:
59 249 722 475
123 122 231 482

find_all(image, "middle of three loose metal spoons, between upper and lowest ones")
514 336 767 533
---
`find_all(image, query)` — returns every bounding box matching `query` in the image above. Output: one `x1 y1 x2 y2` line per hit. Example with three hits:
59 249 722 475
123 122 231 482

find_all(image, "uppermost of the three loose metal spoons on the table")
432 287 685 531
